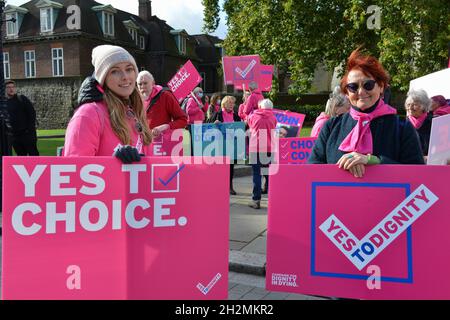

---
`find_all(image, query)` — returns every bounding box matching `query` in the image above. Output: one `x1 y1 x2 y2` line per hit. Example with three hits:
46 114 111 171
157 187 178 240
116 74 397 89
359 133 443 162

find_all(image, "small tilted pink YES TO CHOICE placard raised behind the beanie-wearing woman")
167 60 203 102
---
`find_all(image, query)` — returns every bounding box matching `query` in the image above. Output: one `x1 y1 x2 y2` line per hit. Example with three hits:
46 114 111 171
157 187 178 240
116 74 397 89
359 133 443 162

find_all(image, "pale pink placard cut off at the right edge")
427 114 450 165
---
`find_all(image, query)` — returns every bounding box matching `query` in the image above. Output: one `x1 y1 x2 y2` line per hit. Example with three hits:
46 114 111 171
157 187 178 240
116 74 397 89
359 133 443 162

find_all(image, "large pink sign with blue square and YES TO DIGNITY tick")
266 165 450 299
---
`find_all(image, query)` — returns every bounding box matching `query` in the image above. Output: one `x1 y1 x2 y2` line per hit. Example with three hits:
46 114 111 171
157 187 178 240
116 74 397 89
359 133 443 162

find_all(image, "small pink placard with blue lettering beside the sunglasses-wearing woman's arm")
279 138 316 164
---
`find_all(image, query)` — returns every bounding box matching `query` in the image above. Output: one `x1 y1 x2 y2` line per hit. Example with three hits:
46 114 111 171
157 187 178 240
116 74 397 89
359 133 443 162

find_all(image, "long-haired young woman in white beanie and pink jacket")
64 45 152 163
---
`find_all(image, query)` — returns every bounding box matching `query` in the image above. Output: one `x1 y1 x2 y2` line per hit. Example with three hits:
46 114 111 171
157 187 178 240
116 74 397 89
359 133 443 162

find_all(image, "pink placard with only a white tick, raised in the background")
222 55 260 88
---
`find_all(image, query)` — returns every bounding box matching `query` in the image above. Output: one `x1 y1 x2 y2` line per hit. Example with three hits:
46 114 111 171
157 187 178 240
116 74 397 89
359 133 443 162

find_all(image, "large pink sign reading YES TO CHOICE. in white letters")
2 157 229 300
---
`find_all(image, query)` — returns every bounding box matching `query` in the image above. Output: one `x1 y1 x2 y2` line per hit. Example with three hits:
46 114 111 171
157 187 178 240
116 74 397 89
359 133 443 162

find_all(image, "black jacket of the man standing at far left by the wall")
6 94 36 136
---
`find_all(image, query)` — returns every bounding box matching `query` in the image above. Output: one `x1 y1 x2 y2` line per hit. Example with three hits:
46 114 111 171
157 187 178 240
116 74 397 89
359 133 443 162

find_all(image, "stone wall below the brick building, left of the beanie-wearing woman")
16 77 82 129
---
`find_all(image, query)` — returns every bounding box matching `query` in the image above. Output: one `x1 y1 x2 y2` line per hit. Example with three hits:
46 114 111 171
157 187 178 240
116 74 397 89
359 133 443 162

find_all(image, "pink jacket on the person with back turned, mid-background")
247 109 277 152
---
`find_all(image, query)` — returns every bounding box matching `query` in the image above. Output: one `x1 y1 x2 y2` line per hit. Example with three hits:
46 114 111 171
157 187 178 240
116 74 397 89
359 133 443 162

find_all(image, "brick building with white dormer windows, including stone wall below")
2 0 223 128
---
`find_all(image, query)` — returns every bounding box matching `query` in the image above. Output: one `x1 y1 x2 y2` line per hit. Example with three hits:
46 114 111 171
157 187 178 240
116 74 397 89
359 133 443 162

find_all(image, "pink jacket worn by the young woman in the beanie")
64 102 149 157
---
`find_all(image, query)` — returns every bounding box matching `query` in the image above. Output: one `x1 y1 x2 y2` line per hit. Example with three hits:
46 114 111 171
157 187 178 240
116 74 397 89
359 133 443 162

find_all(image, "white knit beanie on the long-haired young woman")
92 45 139 86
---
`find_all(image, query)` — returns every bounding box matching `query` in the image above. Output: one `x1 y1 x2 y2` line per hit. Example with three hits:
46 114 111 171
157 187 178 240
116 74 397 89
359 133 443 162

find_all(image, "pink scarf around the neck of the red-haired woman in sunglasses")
339 99 397 154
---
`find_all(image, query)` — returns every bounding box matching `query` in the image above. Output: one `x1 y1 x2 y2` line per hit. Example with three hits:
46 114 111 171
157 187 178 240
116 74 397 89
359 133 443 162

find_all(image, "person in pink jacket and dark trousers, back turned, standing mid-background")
247 99 277 209
